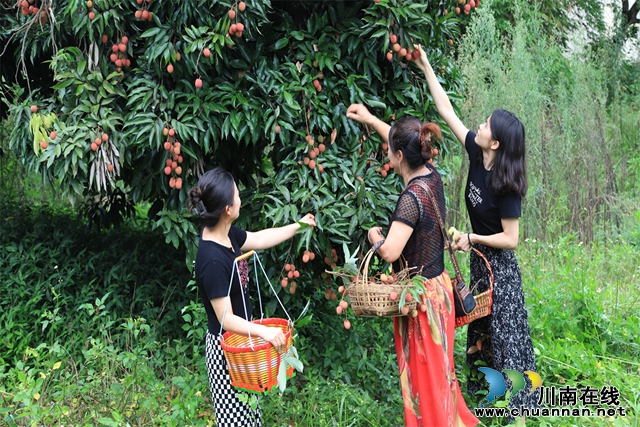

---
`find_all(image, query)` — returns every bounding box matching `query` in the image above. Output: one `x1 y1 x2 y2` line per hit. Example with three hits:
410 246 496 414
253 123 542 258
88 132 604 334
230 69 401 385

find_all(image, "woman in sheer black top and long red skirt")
347 104 478 427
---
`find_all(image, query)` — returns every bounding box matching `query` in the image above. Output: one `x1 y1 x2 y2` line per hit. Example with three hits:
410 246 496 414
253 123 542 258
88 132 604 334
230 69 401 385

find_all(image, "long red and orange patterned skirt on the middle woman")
394 271 479 427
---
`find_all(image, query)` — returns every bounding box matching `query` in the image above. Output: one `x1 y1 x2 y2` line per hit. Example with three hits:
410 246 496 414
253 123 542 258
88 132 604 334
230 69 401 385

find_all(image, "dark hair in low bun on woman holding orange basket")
189 166 235 227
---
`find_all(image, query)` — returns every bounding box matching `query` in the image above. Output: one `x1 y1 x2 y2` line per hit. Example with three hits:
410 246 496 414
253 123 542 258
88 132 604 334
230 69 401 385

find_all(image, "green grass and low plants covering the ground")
0 206 640 427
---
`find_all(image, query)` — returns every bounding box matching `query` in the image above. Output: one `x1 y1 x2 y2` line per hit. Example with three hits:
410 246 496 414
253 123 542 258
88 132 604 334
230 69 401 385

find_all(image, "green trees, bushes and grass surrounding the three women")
0 0 640 426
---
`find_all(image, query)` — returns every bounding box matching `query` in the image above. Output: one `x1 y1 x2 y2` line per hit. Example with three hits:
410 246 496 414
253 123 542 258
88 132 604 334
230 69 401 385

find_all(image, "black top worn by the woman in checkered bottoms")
196 225 252 335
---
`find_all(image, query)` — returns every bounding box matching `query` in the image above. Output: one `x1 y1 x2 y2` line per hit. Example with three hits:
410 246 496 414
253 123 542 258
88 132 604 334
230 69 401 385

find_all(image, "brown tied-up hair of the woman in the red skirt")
389 116 442 170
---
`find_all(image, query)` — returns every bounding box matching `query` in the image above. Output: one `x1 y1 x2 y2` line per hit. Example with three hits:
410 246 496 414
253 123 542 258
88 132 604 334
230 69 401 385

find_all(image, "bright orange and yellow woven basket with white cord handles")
220 318 294 394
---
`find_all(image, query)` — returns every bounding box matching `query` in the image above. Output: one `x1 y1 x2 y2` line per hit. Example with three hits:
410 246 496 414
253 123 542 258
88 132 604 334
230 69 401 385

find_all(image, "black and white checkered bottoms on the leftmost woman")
205 331 262 427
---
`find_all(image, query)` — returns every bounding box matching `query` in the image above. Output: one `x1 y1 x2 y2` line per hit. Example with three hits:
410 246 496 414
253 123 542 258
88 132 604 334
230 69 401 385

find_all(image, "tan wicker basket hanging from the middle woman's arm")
347 250 417 317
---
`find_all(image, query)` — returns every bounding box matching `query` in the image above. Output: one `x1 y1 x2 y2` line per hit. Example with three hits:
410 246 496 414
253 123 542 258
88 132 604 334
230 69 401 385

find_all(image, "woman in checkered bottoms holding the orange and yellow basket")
189 167 316 427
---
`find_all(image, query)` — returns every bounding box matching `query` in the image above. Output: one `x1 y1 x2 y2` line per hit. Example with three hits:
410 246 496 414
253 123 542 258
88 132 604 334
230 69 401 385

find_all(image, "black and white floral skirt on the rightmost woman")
467 245 540 408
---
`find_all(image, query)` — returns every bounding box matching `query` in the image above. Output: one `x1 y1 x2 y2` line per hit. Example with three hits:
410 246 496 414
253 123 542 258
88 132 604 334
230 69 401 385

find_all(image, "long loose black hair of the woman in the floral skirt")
490 109 529 197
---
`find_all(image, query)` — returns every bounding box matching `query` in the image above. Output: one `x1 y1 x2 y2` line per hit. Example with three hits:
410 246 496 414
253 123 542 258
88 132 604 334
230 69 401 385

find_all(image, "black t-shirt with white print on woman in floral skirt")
464 131 522 236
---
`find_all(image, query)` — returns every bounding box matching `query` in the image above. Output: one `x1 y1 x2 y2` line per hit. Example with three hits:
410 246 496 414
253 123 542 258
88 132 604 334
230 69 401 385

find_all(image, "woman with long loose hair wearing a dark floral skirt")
415 46 539 425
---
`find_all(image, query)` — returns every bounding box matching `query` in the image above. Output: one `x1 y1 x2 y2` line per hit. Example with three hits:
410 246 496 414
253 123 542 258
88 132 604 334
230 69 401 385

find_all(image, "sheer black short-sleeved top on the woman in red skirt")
391 164 446 279
